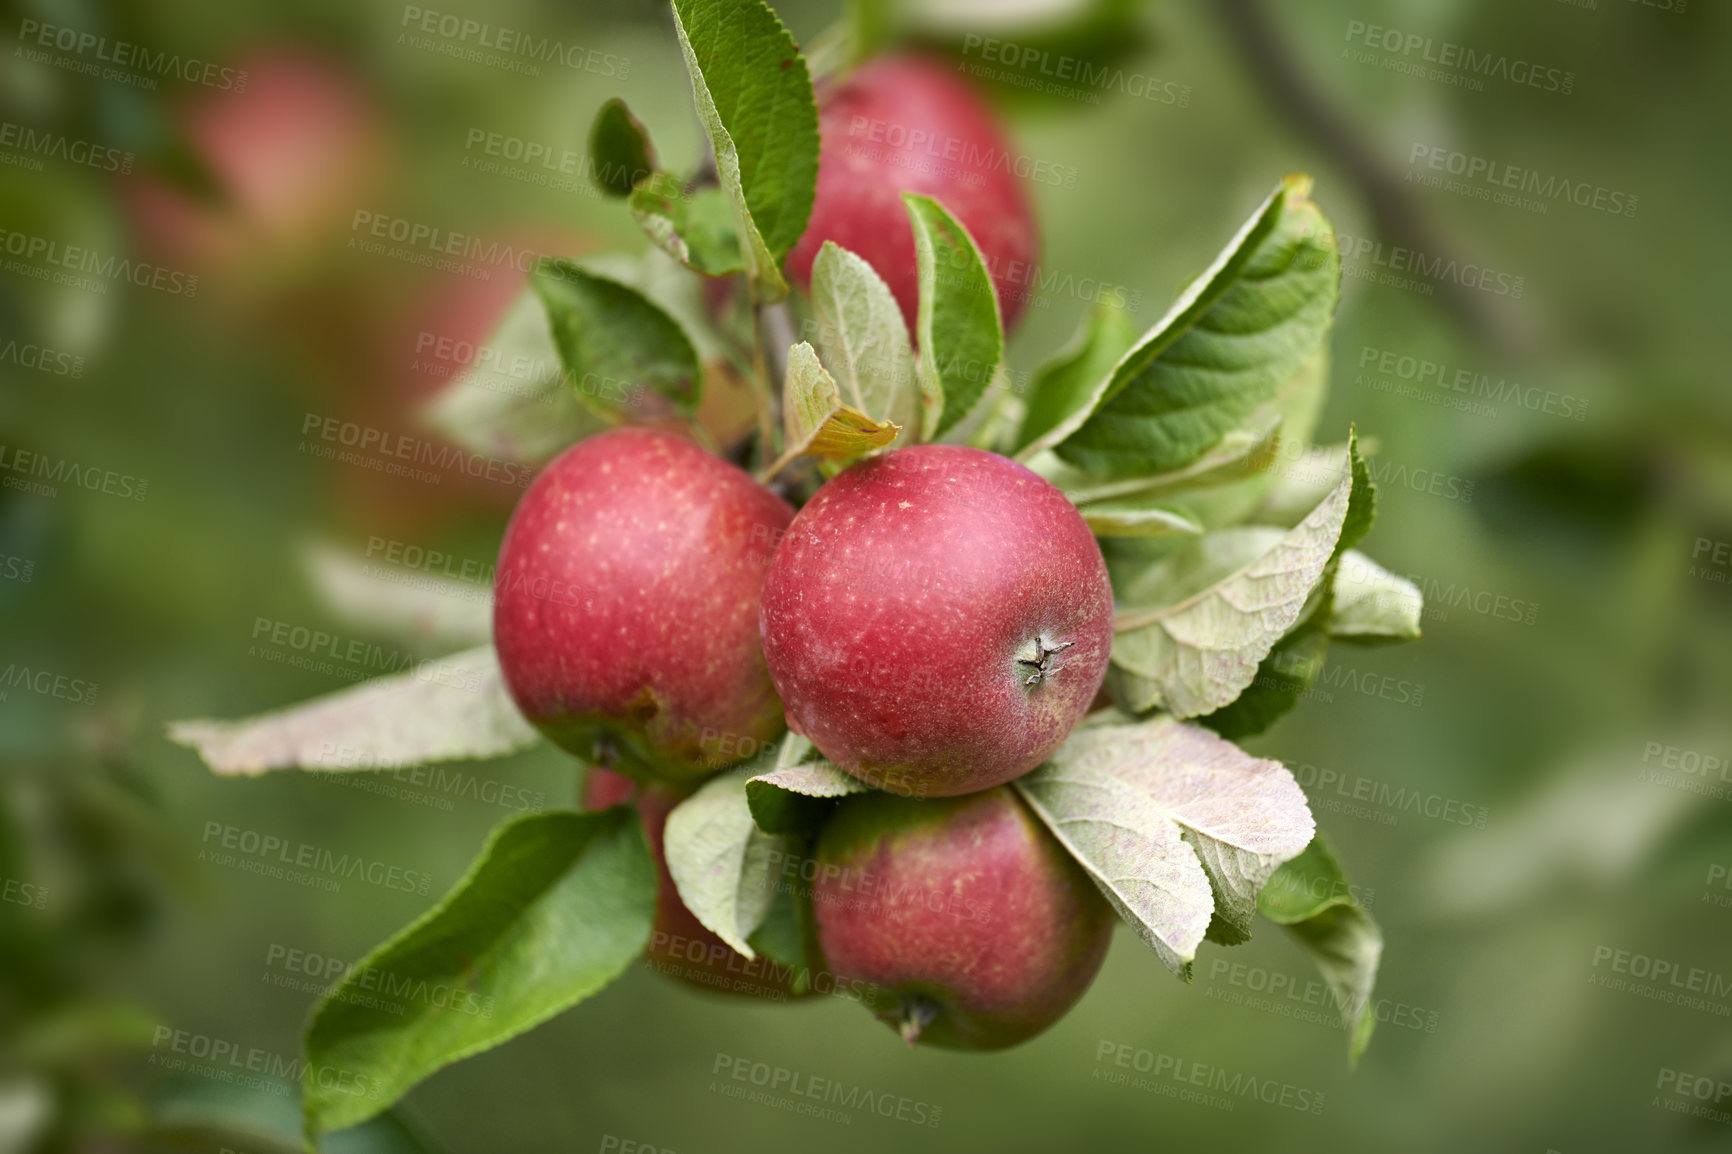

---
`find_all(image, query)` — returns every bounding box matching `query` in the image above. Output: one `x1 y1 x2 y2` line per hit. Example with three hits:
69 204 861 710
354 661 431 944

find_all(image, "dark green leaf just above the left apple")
530 258 703 414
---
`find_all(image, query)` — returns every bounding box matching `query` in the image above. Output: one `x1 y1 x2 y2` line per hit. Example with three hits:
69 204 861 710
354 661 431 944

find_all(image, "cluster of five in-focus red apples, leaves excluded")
494 57 1115 1050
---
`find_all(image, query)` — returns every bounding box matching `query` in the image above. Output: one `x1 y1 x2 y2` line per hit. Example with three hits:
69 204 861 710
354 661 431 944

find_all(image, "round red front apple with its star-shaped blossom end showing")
762 445 1112 797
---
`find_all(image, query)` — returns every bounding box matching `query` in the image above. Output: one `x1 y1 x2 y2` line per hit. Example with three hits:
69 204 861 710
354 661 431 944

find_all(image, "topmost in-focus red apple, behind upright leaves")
788 55 1041 331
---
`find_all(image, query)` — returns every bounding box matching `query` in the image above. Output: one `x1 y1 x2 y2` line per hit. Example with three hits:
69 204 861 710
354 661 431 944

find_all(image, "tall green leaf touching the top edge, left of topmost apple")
674 0 818 303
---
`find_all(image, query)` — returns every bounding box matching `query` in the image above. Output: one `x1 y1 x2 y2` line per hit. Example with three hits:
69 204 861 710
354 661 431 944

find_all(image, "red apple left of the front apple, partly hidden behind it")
494 428 793 780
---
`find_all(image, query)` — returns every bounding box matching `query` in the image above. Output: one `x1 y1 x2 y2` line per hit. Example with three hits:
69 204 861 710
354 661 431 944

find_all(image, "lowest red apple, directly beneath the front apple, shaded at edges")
812 787 1114 1050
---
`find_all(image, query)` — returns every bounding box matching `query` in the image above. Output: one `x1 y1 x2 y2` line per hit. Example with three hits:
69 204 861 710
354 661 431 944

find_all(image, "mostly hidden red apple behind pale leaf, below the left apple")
584 769 800 1002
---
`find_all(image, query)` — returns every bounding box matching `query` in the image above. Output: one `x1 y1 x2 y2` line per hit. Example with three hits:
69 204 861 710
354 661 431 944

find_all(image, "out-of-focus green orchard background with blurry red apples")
0 0 1732 1154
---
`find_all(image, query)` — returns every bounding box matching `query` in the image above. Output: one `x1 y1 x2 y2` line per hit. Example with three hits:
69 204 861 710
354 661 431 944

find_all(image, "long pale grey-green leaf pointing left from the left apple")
168 645 540 775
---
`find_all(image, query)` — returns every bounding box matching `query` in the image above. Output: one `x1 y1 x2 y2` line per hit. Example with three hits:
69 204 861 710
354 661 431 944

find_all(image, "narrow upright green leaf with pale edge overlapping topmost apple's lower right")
902 192 1005 440
